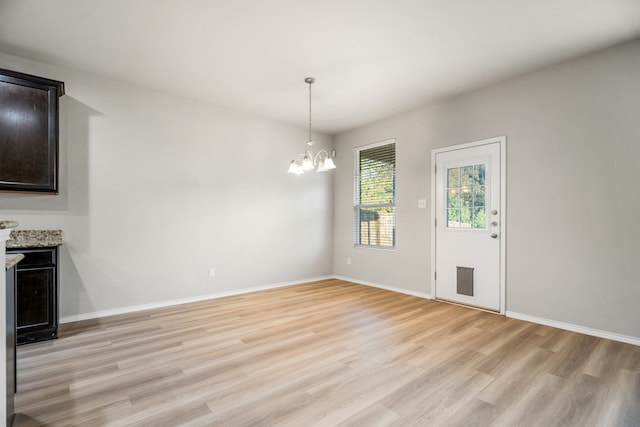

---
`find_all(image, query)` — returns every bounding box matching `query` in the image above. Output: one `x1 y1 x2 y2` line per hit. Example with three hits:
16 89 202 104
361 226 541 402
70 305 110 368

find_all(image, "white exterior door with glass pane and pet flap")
432 137 505 313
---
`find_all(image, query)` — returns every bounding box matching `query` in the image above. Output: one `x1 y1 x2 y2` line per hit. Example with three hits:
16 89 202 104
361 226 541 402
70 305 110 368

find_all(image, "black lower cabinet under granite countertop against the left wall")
7 247 58 345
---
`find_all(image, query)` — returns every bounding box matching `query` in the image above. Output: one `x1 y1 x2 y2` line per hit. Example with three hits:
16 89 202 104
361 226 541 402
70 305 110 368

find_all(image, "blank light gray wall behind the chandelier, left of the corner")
0 54 333 317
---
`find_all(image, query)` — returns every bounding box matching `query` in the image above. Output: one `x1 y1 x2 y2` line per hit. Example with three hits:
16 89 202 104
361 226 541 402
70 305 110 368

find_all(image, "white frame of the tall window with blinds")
352 138 398 251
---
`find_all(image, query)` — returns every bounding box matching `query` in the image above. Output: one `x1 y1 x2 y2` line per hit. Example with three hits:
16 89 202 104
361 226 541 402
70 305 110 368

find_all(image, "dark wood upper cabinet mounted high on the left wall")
0 69 64 194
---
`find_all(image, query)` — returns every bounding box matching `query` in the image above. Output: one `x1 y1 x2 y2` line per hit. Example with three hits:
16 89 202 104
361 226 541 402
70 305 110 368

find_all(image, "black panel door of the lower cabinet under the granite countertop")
16 267 55 334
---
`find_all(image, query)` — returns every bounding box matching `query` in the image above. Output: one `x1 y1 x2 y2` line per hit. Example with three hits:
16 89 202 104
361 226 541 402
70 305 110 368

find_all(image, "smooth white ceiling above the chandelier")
0 0 640 133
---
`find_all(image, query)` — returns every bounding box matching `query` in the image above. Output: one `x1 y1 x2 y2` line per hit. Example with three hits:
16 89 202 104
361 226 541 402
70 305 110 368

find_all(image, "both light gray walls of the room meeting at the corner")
0 40 640 337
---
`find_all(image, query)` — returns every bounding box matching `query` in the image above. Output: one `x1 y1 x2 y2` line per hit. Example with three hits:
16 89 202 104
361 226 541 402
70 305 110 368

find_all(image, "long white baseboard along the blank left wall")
60 276 333 324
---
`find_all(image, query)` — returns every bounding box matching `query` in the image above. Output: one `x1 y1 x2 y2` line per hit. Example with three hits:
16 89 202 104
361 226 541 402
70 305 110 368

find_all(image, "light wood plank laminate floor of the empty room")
16 280 640 427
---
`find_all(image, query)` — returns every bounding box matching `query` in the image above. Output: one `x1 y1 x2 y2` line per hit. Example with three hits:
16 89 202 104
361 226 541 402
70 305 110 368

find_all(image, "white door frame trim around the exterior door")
430 135 507 315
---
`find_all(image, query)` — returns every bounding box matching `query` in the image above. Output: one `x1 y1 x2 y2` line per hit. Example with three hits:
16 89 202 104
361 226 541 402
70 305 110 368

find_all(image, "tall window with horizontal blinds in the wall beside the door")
354 140 396 248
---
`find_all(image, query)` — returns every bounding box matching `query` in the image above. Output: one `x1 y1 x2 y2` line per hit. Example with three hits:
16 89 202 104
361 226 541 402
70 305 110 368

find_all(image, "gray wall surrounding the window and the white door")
334 40 640 337
